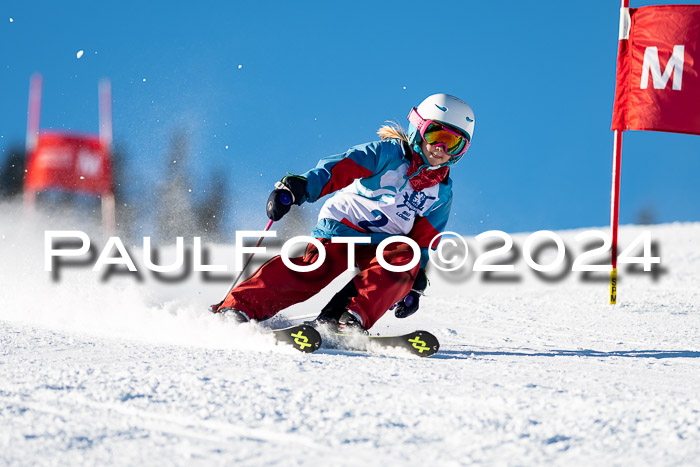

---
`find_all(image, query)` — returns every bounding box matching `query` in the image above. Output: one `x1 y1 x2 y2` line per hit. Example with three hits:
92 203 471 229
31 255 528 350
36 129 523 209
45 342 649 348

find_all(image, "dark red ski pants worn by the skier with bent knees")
221 238 419 329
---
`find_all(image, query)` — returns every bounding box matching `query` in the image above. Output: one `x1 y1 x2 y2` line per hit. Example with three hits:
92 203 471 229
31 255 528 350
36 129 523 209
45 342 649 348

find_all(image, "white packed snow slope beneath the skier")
0 219 700 466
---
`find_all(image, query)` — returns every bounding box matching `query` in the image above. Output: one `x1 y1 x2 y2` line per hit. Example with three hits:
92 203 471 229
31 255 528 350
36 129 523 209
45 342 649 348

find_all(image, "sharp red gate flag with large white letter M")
612 5 700 135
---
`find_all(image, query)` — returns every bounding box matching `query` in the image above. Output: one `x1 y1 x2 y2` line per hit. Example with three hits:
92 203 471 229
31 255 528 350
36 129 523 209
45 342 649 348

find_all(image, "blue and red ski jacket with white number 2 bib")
294 139 452 267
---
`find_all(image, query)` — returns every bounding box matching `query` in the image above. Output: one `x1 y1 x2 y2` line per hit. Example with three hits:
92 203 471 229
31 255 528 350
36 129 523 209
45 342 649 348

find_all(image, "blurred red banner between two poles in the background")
25 132 113 194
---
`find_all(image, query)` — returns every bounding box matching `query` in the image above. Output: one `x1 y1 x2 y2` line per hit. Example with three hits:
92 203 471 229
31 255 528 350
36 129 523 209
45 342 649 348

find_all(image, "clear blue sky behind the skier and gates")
0 0 700 234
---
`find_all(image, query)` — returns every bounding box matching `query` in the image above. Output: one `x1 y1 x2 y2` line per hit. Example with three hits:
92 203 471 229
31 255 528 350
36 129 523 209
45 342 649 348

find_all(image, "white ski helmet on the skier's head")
408 93 474 165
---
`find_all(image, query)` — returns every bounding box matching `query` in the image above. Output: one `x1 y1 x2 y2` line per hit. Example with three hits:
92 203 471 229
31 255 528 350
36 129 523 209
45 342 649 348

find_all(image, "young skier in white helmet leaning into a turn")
210 94 474 331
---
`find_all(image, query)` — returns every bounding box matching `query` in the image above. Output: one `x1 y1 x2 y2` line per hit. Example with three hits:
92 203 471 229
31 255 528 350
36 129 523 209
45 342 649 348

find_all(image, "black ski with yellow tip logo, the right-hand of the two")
332 331 440 357
